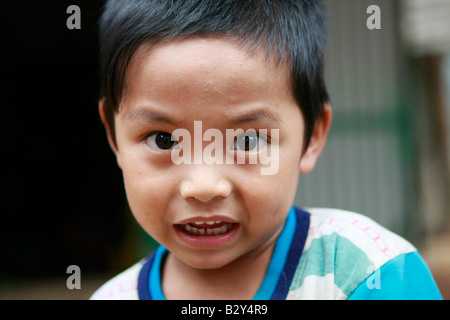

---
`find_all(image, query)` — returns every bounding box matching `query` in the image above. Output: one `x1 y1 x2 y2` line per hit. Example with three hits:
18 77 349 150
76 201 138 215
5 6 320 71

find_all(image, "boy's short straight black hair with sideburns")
99 0 328 150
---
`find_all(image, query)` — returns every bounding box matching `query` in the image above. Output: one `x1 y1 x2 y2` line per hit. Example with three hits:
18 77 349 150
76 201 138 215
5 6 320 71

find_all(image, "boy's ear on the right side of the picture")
300 103 332 173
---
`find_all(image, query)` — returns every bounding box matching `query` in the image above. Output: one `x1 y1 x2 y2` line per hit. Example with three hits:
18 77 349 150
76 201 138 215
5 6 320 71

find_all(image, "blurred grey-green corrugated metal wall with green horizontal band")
295 0 414 234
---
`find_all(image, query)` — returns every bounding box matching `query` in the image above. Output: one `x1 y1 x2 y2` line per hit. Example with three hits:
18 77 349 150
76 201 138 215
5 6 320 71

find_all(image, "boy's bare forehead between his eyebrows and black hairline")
124 37 290 108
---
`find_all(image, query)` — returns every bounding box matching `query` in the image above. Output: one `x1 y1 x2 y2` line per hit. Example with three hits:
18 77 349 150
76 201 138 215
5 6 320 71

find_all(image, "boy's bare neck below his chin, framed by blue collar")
161 234 278 300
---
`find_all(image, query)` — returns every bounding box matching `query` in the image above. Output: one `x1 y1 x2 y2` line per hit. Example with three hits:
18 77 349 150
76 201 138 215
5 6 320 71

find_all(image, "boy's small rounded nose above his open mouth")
180 165 232 203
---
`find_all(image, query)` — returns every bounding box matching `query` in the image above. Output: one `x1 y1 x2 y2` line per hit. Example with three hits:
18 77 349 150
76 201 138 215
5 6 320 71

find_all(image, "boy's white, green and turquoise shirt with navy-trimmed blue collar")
91 207 442 300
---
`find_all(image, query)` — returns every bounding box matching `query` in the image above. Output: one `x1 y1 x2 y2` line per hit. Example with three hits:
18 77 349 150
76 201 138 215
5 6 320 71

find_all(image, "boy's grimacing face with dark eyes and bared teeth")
100 38 327 269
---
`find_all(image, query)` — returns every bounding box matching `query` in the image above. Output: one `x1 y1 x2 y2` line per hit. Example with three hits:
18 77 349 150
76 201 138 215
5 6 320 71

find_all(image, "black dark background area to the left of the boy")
0 0 126 284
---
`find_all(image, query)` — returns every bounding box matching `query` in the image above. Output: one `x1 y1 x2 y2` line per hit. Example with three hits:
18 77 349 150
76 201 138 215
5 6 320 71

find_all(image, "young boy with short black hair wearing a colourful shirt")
92 0 440 299
